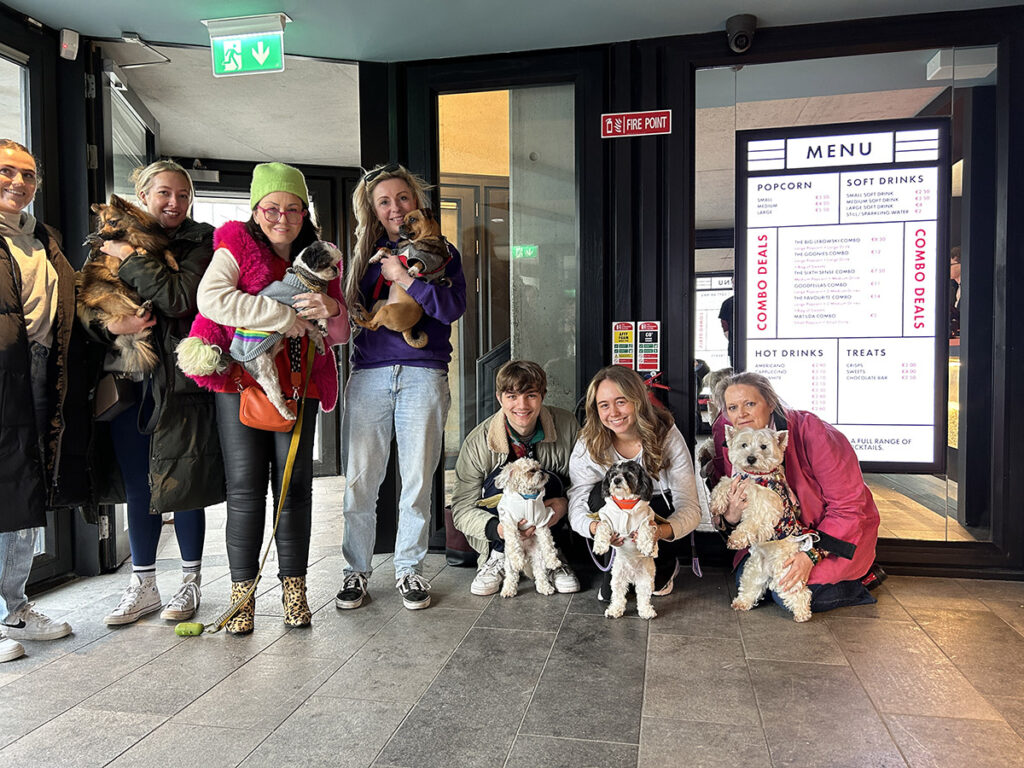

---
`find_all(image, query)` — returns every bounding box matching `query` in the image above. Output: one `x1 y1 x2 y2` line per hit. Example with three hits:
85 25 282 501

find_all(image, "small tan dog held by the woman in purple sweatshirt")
352 208 450 349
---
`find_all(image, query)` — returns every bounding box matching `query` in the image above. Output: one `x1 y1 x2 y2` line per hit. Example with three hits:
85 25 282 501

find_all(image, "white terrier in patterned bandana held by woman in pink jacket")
711 426 811 622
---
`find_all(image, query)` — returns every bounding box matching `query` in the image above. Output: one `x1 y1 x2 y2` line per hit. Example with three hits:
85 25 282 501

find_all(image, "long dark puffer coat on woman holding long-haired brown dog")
89 219 225 514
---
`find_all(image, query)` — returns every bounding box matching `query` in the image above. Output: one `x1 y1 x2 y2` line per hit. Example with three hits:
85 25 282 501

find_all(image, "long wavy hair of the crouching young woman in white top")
580 366 675 477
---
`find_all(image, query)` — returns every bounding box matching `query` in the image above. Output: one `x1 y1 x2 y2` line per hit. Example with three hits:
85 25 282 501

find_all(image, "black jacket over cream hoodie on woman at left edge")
0 223 89 532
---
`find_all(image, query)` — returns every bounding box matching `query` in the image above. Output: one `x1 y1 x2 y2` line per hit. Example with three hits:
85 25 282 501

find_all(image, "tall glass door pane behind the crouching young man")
437 84 580 500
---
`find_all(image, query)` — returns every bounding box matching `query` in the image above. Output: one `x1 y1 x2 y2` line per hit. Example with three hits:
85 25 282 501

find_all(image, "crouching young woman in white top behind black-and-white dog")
569 366 700 601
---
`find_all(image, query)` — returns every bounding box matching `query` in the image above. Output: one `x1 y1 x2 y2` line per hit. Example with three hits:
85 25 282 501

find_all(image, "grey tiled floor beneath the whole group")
0 478 1024 768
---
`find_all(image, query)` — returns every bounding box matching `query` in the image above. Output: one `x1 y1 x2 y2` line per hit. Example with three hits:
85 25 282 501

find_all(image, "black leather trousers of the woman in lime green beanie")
215 393 319 582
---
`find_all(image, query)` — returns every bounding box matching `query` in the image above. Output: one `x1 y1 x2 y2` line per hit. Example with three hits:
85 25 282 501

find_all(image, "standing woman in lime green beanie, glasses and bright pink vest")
190 163 348 635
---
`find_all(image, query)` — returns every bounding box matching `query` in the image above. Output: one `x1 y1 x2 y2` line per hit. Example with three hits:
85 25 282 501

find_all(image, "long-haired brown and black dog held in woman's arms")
75 195 178 374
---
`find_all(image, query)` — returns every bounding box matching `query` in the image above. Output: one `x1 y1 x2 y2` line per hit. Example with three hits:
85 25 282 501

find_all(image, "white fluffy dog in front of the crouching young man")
495 459 561 597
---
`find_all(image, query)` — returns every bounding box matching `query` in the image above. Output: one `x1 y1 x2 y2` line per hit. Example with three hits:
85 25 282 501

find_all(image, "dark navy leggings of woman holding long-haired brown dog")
111 384 206 566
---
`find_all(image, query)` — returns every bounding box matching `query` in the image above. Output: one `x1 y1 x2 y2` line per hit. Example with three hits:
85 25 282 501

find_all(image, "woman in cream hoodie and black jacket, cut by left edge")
0 139 84 662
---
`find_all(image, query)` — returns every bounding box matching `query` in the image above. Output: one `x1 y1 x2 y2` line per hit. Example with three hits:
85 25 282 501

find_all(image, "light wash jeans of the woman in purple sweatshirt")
341 366 452 579
